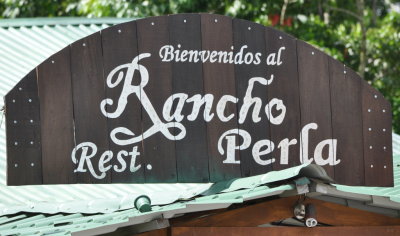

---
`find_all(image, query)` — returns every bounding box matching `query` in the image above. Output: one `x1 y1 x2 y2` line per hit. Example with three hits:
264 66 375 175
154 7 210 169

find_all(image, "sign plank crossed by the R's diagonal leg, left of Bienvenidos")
137 16 177 183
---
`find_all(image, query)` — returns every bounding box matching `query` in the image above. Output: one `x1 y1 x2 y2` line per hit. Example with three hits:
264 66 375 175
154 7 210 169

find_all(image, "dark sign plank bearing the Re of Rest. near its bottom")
71 33 111 183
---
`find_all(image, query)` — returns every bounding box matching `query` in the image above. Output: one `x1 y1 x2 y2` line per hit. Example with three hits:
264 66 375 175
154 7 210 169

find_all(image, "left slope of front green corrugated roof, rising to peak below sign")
0 165 322 235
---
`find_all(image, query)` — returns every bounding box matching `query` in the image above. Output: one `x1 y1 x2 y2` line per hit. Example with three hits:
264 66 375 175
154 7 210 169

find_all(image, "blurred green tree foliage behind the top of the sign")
0 0 400 133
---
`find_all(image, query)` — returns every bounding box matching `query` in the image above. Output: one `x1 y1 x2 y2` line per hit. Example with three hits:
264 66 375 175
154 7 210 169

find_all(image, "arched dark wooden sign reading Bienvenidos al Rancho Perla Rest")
5 14 393 186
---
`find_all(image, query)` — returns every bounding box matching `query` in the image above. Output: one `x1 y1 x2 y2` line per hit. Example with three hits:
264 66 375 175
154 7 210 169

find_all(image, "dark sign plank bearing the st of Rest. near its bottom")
101 21 144 183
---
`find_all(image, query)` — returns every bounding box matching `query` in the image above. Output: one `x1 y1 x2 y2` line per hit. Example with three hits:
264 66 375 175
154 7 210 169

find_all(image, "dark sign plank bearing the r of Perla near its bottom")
266 28 300 170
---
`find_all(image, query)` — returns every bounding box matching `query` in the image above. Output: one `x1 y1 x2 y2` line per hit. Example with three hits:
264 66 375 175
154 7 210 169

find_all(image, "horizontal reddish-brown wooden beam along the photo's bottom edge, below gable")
171 226 400 236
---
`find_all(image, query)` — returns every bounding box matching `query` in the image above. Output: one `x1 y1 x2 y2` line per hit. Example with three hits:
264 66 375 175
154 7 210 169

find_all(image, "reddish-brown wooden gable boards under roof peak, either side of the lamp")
171 196 400 227
